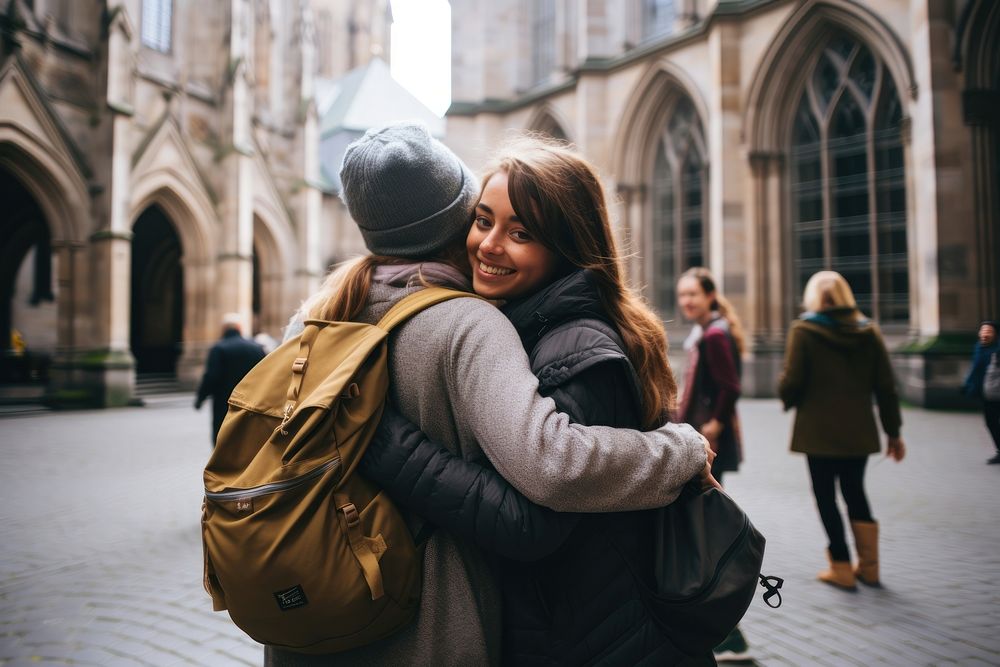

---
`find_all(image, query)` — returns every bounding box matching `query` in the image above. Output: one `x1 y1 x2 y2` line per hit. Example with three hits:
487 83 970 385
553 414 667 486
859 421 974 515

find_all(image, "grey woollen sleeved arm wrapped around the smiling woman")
448 304 706 512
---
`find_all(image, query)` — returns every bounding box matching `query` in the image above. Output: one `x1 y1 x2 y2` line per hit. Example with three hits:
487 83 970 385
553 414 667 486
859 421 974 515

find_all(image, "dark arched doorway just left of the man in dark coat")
131 206 184 375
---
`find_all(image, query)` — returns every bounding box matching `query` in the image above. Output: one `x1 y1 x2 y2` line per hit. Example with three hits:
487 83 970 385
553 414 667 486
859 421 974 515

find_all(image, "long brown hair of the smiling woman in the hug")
483 135 677 428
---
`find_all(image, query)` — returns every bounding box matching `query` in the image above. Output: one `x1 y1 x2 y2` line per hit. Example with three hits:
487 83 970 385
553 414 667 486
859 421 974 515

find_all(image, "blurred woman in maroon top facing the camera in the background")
677 266 750 661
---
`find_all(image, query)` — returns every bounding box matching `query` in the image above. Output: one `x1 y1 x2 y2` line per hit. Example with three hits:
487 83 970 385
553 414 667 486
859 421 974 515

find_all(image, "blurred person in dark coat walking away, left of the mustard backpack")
194 313 264 447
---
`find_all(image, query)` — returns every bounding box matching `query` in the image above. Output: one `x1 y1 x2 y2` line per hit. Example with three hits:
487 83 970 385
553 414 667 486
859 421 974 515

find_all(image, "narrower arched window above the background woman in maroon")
650 97 708 319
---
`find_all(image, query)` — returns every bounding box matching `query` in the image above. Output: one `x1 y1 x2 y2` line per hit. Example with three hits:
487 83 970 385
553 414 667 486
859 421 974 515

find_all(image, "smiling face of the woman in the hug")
465 172 559 299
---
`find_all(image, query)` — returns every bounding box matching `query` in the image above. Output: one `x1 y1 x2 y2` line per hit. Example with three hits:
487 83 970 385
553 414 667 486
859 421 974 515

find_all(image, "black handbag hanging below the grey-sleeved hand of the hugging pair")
647 484 783 656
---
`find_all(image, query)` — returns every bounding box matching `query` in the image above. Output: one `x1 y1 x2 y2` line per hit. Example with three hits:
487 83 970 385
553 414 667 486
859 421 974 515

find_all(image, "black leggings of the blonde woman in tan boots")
807 456 874 561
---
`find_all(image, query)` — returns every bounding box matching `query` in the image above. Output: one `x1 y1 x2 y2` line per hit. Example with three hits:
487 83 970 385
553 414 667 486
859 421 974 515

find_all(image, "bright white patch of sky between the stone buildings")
390 0 451 116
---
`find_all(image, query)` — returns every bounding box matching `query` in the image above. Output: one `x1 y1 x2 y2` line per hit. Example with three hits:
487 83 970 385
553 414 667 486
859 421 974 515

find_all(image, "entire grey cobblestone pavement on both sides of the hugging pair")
0 396 1000 667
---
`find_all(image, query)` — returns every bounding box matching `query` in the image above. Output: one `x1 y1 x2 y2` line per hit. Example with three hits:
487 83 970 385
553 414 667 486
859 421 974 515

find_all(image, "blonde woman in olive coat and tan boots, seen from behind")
778 271 906 590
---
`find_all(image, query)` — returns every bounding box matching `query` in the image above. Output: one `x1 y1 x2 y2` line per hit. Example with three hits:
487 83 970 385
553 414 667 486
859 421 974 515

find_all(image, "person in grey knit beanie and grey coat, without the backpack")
265 123 708 667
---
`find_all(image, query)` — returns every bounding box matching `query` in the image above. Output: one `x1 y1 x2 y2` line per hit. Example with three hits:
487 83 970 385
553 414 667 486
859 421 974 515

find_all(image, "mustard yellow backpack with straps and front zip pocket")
202 287 471 653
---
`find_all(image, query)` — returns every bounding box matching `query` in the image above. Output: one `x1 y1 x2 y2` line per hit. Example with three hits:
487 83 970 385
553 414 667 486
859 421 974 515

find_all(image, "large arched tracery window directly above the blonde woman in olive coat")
790 33 909 323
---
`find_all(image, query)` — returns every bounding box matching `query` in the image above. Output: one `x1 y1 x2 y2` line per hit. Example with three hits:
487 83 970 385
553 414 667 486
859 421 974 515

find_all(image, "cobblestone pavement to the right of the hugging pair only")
726 401 1000 667
